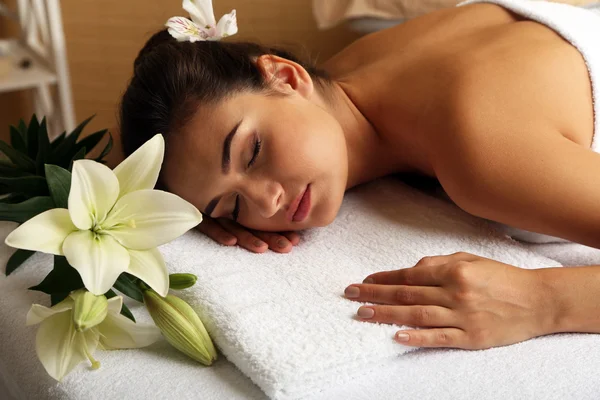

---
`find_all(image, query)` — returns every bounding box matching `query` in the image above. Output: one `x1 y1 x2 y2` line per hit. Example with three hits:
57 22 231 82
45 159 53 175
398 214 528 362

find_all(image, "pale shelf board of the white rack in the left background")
0 40 57 92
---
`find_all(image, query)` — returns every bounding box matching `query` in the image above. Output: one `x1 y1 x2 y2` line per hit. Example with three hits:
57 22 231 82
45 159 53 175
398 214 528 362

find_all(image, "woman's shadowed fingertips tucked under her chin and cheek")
197 215 300 253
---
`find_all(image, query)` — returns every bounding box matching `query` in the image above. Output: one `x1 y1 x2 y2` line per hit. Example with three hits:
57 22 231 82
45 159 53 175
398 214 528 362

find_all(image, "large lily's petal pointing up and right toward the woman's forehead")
114 134 165 197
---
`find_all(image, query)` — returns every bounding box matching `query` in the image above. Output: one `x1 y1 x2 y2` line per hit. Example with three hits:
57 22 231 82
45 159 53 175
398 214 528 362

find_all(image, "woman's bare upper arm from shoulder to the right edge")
432 119 600 248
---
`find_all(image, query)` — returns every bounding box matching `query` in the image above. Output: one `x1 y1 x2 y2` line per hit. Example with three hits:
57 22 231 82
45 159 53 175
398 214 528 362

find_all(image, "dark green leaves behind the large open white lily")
0 115 113 278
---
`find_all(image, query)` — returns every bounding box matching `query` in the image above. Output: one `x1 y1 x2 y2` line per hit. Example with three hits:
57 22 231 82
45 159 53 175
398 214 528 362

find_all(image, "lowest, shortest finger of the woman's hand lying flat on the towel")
394 328 471 349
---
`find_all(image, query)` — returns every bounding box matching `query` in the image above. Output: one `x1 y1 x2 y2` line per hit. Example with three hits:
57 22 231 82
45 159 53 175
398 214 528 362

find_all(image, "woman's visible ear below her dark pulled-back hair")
256 54 314 98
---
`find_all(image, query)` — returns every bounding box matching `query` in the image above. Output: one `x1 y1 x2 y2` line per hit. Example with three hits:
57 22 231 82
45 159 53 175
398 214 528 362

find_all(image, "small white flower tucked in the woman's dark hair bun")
165 0 238 43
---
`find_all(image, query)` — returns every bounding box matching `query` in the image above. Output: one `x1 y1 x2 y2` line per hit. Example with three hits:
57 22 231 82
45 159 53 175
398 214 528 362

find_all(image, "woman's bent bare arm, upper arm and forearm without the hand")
422 114 600 333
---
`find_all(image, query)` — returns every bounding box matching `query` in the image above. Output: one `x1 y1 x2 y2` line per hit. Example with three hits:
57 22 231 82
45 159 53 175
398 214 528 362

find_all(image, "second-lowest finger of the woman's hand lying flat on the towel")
356 306 458 327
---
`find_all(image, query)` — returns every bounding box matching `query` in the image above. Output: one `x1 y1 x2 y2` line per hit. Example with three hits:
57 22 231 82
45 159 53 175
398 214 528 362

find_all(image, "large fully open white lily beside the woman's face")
5 135 202 296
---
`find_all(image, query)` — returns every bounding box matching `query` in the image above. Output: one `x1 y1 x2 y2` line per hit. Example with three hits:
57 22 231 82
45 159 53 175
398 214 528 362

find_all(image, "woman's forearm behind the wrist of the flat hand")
536 265 600 333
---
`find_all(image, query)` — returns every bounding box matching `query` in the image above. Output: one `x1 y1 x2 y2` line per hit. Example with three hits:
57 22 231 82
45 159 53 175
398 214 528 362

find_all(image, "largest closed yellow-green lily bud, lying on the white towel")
144 289 217 365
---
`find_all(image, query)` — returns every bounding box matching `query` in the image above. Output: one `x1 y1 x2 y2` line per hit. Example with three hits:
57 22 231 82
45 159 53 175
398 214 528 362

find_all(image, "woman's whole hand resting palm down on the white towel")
345 253 554 349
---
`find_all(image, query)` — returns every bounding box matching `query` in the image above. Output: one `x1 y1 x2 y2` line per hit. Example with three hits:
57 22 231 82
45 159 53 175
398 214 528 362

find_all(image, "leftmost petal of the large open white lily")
4 208 77 256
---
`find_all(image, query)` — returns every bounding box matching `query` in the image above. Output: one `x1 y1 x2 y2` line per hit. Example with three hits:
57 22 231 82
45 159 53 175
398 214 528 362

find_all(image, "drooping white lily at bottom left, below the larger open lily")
27 291 160 381
